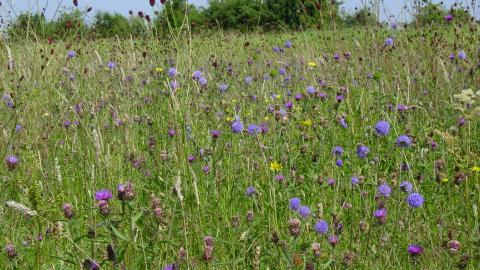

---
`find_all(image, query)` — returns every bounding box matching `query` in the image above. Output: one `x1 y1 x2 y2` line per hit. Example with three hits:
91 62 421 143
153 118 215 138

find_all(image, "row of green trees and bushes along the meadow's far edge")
5 0 476 39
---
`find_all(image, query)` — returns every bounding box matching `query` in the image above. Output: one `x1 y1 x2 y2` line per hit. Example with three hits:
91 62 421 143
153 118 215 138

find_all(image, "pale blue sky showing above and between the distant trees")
0 0 480 21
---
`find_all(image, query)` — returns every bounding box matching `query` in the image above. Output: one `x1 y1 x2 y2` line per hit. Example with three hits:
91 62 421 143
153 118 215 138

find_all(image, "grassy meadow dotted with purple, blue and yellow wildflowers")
0 25 480 269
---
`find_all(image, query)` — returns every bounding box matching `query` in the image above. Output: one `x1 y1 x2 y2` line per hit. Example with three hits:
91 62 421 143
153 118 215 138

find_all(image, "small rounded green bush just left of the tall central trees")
93 12 132 37
